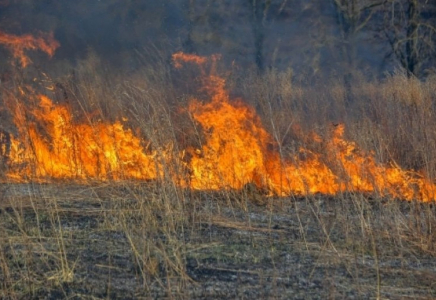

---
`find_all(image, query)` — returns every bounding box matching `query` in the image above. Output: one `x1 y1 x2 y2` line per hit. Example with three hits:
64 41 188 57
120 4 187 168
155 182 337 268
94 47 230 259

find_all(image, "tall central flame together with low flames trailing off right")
173 53 436 201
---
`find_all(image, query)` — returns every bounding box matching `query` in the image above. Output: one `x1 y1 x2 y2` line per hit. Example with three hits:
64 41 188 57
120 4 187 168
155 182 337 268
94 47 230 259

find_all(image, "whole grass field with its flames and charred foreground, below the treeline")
0 37 436 299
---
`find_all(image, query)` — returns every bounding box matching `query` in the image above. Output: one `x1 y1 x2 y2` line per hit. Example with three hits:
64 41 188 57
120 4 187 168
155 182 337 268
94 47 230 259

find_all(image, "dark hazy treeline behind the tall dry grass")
0 0 436 78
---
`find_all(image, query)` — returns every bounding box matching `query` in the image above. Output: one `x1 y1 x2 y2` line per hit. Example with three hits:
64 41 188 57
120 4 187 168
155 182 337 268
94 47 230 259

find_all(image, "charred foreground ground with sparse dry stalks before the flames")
0 184 436 299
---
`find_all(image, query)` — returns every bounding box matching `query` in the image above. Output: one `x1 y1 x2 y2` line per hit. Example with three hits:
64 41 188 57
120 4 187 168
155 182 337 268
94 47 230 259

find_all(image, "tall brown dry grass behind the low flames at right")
237 70 436 178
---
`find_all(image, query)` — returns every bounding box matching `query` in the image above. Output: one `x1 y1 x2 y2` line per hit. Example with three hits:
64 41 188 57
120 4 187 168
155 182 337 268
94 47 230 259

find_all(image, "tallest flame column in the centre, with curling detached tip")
173 53 270 190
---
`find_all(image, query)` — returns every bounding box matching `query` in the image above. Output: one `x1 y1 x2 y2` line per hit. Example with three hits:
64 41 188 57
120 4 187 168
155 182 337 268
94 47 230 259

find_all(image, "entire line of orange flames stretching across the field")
0 53 436 201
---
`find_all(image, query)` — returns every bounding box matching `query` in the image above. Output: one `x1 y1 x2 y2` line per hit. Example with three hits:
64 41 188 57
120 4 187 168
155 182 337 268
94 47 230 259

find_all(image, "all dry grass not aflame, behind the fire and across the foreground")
0 54 436 299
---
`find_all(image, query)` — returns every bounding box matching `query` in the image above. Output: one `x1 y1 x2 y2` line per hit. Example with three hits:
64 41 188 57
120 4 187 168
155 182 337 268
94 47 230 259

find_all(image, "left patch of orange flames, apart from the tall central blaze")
8 95 158 181
